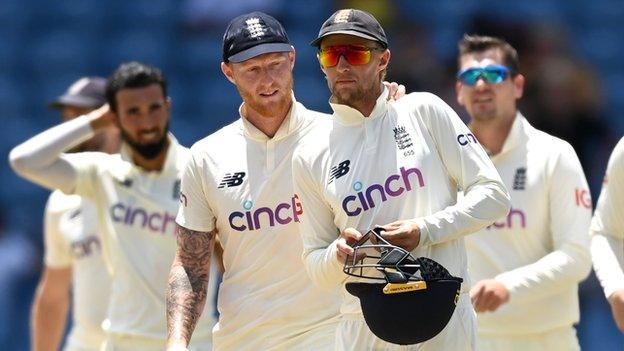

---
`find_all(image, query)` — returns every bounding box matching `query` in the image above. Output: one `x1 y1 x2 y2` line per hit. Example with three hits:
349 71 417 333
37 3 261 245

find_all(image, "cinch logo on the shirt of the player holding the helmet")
342 167 425 217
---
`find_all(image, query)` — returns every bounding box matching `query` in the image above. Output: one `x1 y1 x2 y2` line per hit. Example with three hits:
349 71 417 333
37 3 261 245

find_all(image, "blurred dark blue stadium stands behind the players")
0 0 624 350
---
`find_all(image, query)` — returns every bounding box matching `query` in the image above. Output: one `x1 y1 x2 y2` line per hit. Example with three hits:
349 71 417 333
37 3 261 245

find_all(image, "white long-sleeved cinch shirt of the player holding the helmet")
293 91 509 346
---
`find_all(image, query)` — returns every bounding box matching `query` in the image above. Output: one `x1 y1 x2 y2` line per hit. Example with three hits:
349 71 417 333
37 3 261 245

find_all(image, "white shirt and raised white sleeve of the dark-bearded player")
10 116 214 349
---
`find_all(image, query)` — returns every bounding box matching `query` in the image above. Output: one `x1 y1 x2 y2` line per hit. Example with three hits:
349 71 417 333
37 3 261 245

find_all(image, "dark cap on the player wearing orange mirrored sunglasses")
310 9 388 48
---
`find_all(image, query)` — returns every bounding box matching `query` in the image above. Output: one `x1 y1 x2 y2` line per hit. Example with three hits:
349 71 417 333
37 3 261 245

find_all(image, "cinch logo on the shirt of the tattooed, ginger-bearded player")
228 194 303 232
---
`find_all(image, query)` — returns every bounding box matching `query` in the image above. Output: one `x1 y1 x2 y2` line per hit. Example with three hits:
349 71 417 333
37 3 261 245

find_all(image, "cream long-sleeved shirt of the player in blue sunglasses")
466 113 591 335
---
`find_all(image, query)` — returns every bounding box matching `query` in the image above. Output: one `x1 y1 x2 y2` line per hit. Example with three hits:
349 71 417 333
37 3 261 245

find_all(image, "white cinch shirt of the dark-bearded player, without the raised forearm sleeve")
69 135 211 341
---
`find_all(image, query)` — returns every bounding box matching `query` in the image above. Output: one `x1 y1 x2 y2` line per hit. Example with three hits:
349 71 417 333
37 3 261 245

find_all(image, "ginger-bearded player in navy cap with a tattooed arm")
167 12 404 350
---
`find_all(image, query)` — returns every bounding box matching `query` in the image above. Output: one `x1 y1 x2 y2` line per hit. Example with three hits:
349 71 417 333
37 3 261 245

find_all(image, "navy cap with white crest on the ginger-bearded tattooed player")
223 11 293 63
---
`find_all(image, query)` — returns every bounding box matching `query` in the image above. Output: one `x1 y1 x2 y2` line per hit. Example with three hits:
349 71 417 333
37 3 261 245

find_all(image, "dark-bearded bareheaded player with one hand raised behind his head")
9 62 217 351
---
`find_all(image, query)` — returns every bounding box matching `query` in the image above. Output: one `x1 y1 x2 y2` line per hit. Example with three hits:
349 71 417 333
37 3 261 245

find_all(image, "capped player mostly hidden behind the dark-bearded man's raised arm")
30 77 119 351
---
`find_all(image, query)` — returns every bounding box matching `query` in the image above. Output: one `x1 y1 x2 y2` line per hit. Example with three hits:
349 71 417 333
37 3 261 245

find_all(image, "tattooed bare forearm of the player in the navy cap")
167 226 216 345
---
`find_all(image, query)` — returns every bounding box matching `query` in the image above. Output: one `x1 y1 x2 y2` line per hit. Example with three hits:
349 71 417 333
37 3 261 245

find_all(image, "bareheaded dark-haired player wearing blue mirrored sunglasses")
456 35 591 351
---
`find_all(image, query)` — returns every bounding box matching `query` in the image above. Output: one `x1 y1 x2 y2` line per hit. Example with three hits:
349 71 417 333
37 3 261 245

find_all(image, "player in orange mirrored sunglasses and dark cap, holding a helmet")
293 9 509 350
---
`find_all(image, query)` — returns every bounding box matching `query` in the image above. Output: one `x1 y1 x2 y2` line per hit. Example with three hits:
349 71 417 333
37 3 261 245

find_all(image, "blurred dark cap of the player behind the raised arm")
49 77 106 108
